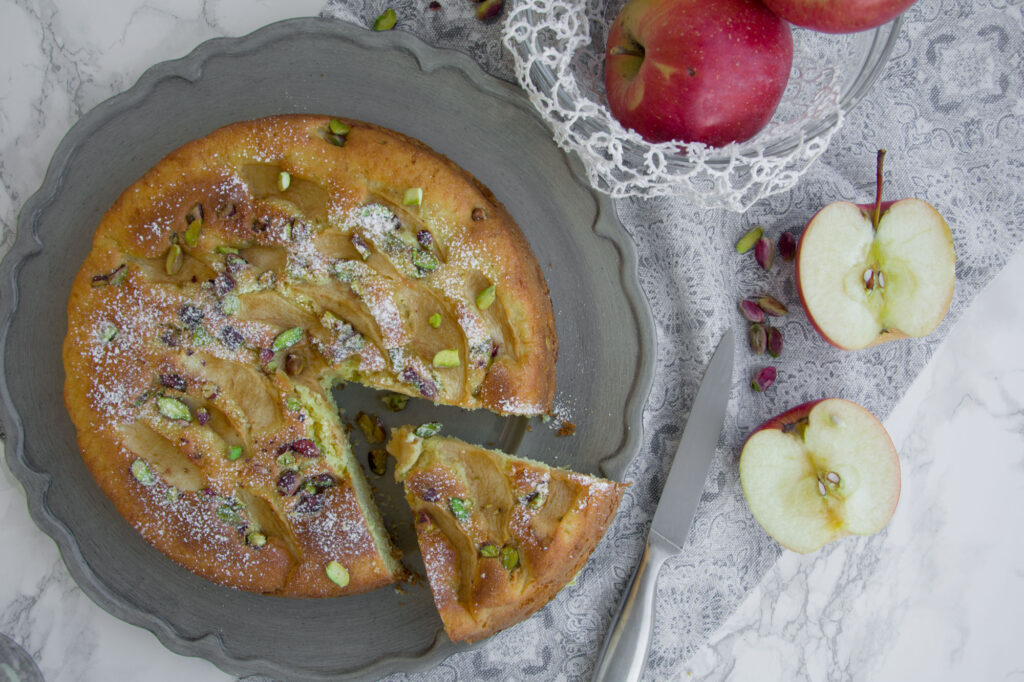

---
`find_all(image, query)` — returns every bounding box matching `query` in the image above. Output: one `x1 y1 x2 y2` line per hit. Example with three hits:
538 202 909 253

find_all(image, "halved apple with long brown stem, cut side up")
796 151 956 350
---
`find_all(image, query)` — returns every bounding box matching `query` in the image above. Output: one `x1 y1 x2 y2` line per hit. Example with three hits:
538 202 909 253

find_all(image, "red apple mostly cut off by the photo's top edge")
764 0 916 33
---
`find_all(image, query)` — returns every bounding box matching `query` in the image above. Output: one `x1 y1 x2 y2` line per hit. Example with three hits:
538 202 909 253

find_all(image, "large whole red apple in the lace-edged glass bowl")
604 0 793 146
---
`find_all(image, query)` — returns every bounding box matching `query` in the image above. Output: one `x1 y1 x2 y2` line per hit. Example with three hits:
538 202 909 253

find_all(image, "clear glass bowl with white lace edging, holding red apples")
503 0 898 212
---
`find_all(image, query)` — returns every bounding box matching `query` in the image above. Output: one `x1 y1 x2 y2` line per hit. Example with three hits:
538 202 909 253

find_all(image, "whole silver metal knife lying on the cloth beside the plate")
594 330 734 682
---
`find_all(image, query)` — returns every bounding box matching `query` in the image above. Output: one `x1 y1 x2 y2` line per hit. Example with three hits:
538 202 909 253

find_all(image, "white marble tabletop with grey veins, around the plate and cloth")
0 0 1024 680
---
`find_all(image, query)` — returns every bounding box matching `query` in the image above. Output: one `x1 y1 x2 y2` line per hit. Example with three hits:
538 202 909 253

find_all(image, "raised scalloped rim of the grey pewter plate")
0 16 657 679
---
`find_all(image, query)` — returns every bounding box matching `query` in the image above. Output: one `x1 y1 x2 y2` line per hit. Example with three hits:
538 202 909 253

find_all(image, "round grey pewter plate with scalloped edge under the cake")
0 18 654 679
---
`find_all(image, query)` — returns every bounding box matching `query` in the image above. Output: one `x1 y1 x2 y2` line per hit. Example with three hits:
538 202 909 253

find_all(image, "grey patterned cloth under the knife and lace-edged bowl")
324 0 1024 680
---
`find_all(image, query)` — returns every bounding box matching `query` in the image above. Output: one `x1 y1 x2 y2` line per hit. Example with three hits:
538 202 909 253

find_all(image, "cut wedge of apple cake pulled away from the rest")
387 425 626 641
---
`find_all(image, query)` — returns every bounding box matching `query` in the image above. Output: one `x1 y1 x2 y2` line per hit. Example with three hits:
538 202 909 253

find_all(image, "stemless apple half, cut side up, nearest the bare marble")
739 398 900 554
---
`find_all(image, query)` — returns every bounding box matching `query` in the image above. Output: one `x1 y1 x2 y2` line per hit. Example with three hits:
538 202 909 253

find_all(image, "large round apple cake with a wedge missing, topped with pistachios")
63 115 557 596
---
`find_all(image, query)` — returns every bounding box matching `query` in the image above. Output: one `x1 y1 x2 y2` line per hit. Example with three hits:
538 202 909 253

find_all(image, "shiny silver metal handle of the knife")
594 534 669 682
